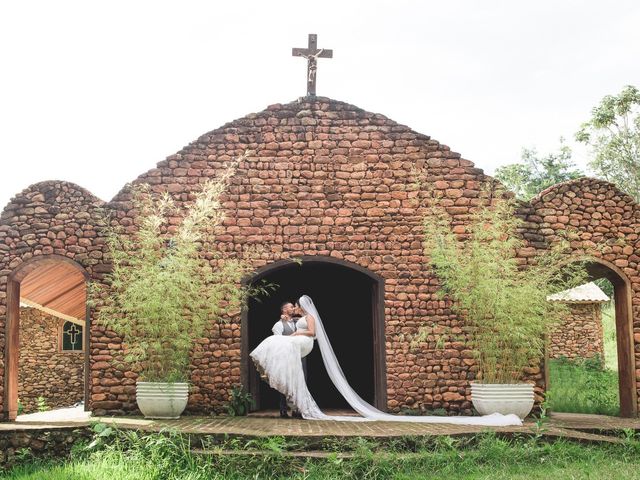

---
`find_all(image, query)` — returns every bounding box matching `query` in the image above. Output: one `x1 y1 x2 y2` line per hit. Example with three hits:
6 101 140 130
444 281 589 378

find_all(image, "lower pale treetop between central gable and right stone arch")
495 138 582 200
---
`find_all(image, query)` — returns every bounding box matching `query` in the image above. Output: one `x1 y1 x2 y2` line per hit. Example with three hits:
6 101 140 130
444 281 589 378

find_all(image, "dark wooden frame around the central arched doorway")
240 255 387 411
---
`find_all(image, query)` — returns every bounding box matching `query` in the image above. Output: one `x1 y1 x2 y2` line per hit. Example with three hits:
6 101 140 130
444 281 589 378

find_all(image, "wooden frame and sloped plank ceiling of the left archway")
3 254 89 420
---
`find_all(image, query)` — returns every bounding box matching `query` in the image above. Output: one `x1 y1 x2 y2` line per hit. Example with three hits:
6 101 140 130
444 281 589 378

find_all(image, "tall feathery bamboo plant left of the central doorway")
90 156 250 382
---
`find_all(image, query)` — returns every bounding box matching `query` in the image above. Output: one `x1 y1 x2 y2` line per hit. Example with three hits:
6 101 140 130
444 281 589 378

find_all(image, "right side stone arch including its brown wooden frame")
518 177 640 417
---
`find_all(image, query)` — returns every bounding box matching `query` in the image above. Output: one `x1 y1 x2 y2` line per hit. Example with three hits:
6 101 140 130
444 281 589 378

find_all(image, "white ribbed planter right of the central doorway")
471 382 533 419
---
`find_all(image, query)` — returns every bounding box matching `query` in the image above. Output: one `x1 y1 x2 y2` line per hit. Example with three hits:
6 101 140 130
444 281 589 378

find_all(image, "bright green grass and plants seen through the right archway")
547 357 620 416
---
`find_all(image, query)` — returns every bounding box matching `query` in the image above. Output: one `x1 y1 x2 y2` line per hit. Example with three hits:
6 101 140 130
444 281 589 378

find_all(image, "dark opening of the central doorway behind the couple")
242 256 387 410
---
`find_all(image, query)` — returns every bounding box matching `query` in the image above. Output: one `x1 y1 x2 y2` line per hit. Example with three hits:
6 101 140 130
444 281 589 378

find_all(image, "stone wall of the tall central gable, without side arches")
104 97 500 413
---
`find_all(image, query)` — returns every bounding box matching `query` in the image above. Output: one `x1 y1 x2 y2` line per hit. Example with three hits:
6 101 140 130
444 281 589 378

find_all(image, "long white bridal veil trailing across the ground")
299 295 522 426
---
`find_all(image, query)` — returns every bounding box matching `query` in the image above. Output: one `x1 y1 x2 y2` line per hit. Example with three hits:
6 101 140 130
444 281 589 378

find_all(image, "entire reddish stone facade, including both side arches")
0 97 640 414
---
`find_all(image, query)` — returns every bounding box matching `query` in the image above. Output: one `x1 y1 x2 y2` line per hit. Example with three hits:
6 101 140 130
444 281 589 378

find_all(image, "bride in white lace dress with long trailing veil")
250 295 522 426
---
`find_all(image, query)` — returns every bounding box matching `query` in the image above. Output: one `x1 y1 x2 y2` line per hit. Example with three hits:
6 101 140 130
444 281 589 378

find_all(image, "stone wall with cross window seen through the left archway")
18 308 84 413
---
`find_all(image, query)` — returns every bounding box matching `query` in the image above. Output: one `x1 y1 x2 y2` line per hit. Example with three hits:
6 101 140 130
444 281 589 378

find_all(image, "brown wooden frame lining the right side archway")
545 257 638 417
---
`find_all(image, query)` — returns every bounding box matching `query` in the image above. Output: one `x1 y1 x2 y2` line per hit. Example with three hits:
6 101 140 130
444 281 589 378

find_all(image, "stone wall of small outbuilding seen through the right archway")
549 303 604 359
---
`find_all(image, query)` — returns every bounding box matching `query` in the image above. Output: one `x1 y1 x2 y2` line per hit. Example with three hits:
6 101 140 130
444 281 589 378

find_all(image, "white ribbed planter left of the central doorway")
136 382 189 419
